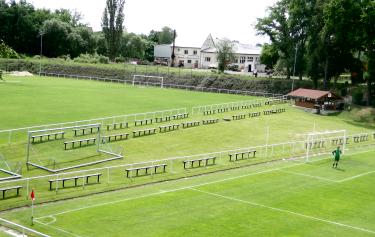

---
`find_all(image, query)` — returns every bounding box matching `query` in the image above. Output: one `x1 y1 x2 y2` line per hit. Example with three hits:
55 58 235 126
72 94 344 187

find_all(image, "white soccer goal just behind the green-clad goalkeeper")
304 130 348 162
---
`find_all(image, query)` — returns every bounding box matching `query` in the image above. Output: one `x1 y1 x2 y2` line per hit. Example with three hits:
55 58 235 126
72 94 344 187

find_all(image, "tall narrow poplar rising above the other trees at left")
102 0 125 60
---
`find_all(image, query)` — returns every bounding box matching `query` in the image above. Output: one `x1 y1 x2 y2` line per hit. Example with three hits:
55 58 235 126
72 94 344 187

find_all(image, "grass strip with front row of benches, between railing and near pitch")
0 133 375 211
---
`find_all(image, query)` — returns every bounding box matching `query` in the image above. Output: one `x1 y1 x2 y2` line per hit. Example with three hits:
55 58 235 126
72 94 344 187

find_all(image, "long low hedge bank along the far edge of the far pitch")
0 59 313 94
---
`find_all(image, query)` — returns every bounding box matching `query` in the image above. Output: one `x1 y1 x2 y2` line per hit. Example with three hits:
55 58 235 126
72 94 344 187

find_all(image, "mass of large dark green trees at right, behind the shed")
256 0 375 103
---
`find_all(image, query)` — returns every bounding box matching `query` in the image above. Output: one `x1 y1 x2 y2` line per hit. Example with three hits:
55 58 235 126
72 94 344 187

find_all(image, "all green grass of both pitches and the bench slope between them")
0 73 375 236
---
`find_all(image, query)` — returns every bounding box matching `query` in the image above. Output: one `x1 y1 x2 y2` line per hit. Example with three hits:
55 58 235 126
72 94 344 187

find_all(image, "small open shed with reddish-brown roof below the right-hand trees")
288 88 343 111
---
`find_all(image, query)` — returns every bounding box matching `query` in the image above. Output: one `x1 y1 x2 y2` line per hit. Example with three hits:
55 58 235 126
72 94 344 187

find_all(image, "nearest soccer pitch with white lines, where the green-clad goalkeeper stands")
3 149 375 236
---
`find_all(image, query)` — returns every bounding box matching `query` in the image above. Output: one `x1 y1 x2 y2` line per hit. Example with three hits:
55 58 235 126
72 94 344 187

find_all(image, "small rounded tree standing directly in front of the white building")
216 39 235 72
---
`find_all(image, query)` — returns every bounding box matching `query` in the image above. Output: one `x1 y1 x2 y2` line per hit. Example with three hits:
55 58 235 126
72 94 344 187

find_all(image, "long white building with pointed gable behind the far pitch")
154 34 265 72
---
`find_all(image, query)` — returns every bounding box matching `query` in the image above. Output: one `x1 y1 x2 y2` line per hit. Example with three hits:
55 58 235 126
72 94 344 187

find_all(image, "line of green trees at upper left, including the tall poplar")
0 0 173 61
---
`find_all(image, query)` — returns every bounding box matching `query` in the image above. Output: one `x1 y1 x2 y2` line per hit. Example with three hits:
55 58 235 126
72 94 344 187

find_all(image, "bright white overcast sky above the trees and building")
28 0 277 47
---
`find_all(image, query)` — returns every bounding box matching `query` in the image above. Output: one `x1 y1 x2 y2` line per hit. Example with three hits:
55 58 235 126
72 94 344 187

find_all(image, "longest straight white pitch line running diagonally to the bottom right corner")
190 188 375 234
